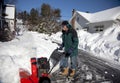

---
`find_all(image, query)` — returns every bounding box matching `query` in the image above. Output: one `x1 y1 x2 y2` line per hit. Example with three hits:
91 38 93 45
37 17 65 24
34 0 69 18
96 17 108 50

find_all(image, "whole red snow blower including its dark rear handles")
19 49 64 83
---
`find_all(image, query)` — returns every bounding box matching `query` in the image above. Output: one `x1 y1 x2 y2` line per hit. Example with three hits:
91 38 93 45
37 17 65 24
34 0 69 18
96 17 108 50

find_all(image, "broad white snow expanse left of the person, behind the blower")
0 32 57 83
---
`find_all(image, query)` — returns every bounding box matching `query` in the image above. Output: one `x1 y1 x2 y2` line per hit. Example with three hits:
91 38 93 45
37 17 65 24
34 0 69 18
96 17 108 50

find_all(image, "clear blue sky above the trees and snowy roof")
17 0 120 20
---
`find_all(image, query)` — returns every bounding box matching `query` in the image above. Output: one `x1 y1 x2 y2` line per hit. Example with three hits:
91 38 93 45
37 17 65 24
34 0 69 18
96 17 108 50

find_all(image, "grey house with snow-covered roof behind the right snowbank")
70 6 120 33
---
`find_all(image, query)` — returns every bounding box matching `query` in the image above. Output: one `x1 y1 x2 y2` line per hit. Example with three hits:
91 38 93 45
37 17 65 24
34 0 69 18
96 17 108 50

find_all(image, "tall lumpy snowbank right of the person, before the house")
78 25 120 61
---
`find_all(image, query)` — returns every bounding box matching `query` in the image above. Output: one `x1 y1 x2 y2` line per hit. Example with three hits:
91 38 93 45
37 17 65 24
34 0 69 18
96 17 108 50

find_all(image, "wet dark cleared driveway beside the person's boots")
51 50 120 83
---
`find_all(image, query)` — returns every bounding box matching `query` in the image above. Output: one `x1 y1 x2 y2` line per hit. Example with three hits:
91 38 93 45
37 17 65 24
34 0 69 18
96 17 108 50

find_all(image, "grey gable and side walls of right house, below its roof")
71 12 120 33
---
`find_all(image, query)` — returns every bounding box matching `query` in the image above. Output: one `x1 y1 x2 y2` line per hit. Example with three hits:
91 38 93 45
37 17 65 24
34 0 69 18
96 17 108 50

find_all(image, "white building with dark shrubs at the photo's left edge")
0 0 16 41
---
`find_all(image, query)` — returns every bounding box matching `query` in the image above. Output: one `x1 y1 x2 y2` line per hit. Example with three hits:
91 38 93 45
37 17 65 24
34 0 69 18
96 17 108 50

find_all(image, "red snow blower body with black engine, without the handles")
19 57 51 83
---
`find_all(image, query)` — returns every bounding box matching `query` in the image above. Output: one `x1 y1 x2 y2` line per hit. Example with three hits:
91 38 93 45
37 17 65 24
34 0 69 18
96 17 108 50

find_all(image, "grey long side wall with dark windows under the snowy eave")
88 21 114 33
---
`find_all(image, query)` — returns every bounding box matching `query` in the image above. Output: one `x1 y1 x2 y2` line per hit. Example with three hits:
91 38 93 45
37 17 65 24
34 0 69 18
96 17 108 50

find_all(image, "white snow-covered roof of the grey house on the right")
75 6 120 23
